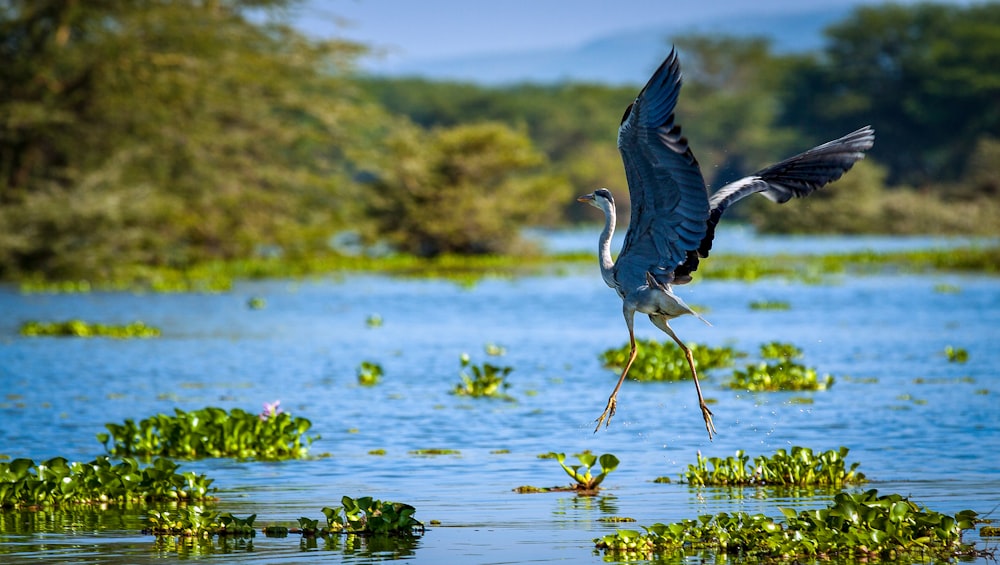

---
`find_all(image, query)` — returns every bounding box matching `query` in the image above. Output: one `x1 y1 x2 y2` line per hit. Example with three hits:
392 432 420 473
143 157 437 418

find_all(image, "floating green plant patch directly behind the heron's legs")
600 339 743 381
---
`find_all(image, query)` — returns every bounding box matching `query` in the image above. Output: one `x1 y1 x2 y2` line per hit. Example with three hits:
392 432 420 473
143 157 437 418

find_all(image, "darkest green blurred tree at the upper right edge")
781 2 1000 186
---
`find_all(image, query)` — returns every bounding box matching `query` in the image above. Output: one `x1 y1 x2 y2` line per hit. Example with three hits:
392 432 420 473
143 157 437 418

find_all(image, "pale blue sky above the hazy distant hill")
288 0 967 63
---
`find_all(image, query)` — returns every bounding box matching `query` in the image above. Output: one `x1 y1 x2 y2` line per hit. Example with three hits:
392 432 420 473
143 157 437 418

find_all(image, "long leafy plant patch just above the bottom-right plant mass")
681 446 867 487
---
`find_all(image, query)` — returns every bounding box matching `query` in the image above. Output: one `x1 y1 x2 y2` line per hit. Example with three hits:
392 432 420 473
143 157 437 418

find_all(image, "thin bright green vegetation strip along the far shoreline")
9 246 1000 293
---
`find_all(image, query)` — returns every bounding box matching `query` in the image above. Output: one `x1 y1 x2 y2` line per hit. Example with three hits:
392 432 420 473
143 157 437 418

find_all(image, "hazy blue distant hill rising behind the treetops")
356 6 851 85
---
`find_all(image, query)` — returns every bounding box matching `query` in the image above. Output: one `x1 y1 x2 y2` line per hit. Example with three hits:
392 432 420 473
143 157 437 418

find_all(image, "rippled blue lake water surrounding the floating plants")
0 234 1000 563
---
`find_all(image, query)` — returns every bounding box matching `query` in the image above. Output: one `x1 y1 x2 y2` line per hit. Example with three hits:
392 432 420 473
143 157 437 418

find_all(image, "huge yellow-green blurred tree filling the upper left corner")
0 0 378 277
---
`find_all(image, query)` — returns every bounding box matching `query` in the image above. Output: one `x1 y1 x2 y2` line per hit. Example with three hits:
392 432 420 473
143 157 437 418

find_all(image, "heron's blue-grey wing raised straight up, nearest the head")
615 50 709 286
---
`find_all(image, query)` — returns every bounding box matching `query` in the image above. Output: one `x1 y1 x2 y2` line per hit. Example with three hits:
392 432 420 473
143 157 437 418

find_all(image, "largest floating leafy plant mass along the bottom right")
594 490 981 561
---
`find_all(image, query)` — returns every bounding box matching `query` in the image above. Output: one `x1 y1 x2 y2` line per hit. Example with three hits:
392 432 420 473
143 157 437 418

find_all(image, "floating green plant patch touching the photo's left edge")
0 456 214 508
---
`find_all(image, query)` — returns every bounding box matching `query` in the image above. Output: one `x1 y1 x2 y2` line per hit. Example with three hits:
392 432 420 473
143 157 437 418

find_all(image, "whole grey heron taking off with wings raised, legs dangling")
577 49 875 440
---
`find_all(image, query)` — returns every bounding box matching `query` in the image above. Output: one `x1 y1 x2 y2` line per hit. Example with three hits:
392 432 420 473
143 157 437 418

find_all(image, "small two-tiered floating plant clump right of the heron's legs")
729 342 833 392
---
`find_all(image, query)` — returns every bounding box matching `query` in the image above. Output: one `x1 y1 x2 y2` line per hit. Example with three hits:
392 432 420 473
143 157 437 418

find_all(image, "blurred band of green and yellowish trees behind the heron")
0 0 1000 279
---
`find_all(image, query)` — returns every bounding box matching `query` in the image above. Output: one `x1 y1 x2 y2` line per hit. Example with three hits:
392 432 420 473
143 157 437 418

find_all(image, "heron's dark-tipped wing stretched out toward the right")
675 126 875 280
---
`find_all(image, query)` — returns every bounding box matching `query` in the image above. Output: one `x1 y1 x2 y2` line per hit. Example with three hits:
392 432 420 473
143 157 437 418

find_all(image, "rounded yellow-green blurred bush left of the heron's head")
365 122 570 257
